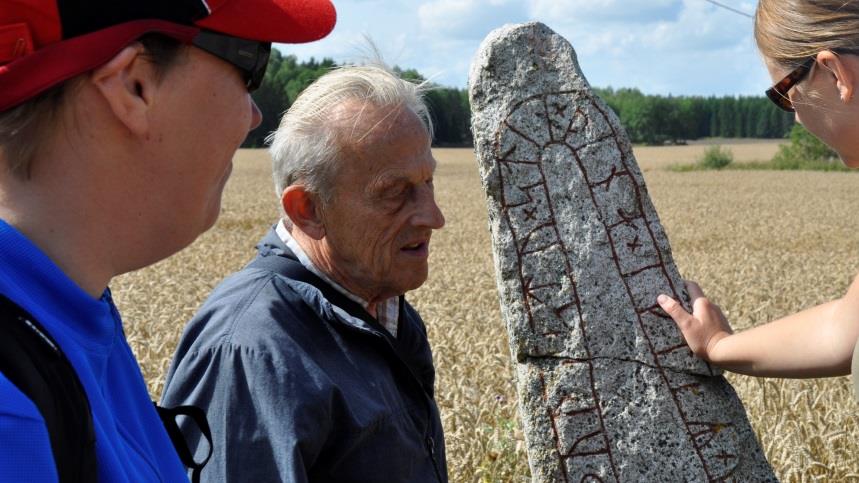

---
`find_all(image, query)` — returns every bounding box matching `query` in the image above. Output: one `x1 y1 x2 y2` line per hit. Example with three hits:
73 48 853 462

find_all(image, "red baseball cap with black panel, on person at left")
0 0 337 112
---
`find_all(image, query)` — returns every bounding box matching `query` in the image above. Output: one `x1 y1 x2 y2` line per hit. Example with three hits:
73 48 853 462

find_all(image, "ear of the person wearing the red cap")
90 42 158 136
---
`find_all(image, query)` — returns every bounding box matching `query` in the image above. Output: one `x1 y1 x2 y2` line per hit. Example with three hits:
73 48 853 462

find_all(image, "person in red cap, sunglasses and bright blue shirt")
0 0 335 482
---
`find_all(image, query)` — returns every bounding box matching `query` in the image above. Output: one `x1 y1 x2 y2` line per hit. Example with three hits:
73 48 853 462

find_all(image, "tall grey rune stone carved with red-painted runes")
469 23 776 482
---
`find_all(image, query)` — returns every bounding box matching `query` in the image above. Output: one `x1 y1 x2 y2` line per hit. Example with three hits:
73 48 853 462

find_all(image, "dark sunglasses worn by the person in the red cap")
191 30 271 92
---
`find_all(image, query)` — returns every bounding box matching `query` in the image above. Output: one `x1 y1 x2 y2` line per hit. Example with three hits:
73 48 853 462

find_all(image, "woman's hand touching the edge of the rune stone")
656 281 734 365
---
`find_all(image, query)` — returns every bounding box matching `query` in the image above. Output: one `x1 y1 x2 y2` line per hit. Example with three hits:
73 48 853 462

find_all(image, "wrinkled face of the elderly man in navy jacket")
322 103 444 302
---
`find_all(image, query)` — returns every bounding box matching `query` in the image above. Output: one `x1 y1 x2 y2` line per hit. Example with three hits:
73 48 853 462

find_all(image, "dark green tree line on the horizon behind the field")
243 53 794 147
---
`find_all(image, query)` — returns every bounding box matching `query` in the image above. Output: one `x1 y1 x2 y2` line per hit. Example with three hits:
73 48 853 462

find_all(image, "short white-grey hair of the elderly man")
266 61 433 203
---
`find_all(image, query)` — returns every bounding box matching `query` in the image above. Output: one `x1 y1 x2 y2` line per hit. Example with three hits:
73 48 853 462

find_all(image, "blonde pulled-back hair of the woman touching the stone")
755 0 859 68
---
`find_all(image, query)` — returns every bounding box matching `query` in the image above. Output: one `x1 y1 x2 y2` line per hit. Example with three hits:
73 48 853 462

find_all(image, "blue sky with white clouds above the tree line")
278 0 770 96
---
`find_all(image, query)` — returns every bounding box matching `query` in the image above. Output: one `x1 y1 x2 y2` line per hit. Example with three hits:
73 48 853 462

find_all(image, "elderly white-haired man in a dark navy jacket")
163 66 447 482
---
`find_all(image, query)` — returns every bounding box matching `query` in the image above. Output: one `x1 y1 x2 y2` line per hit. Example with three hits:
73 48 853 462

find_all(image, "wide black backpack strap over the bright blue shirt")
0 294 97 483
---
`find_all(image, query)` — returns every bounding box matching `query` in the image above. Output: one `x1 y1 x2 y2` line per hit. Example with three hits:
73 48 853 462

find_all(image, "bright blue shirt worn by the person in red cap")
0 220 188 483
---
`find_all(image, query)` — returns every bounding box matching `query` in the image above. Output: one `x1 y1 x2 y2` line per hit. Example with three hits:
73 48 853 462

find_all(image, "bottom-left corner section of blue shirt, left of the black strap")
0 373 57 483
